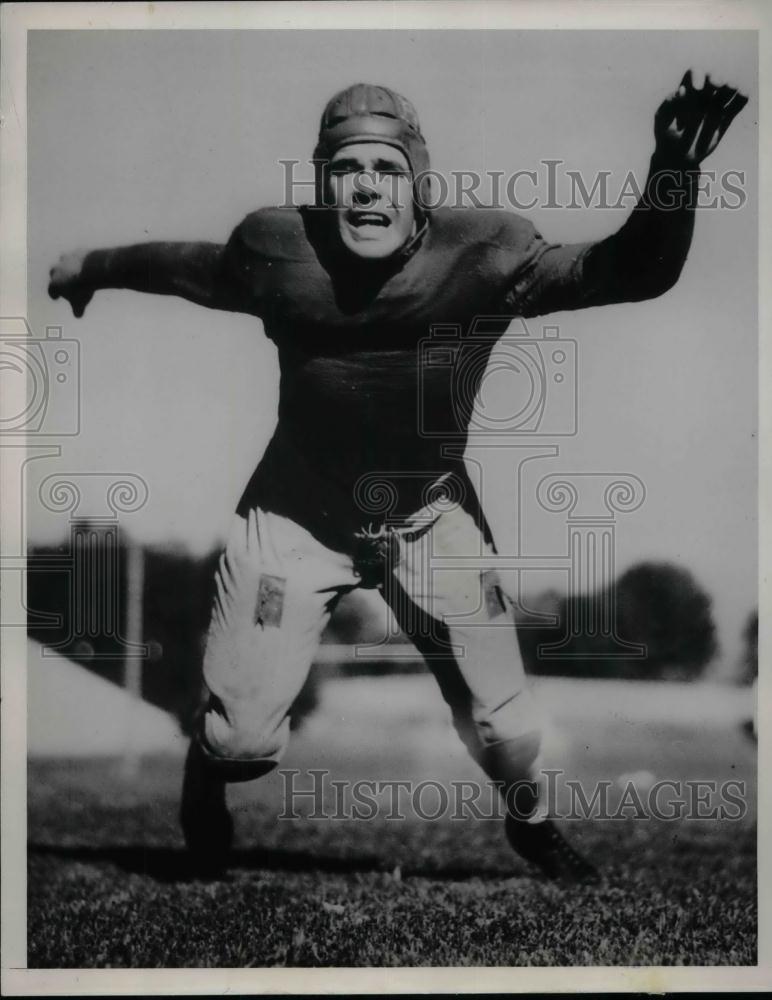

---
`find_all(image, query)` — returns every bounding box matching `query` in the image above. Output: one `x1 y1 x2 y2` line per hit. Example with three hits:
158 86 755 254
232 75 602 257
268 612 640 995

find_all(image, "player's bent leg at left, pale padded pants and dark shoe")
180 510 358 871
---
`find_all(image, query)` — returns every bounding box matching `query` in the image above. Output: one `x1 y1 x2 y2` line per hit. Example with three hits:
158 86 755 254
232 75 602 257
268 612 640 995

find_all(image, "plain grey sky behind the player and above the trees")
28 30 758 660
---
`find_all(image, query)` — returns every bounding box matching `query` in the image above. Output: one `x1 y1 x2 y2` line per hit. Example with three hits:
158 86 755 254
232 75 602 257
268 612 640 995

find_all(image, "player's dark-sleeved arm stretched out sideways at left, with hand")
48 232 253 316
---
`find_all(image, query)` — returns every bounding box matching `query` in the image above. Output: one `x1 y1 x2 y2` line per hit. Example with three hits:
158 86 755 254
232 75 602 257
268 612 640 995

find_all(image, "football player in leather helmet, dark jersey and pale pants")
49 72 747 881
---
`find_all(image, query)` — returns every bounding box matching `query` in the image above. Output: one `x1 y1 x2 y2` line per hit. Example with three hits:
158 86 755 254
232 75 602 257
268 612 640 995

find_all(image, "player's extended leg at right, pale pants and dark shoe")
386 507 594 880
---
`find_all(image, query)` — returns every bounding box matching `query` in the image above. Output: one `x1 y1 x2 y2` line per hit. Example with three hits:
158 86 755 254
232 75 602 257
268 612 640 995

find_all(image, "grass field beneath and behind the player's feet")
28 676 756 968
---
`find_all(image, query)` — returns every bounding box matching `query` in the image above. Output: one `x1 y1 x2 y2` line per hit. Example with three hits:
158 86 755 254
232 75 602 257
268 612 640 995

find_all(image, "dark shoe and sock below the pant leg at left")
180 739 233 878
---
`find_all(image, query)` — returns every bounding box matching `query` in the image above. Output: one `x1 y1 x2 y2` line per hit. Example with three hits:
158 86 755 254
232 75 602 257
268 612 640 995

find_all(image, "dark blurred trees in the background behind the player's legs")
27 525 740 722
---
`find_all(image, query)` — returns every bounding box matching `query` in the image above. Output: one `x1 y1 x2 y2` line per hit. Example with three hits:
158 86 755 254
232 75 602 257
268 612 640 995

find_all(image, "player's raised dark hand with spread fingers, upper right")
654 69 748 166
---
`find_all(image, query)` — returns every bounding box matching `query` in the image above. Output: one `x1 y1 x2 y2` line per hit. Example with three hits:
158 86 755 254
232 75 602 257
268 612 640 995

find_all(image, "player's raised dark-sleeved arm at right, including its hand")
518 70 748 315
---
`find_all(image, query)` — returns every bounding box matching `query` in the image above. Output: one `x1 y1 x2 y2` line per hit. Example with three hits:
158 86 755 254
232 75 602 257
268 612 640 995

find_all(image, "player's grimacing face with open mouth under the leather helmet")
328 142 415 260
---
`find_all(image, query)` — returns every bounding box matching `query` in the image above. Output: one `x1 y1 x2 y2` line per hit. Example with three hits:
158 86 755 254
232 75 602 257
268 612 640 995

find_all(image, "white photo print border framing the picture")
0 0 772 996
